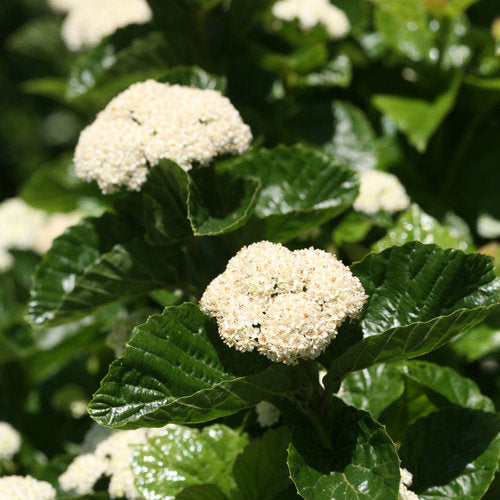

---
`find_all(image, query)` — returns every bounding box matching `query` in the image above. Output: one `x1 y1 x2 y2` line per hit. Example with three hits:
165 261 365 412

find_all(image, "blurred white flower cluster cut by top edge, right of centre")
272 0 351 38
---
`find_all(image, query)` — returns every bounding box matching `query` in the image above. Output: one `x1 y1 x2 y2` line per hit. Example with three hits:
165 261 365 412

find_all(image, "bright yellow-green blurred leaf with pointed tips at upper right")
372 76 461 152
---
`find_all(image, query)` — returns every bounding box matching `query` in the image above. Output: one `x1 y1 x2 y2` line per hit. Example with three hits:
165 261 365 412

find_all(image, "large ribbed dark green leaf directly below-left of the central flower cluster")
89 303 300 429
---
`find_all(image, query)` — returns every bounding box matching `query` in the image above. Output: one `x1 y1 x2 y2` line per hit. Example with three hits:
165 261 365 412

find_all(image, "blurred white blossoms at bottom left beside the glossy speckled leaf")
59 429 164 499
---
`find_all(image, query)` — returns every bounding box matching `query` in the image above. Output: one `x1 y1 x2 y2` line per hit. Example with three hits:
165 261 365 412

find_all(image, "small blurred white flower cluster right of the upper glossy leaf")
353 170 410 215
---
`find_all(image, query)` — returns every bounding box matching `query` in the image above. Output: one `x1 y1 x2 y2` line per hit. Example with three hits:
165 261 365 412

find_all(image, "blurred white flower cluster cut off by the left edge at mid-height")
0 198 81 271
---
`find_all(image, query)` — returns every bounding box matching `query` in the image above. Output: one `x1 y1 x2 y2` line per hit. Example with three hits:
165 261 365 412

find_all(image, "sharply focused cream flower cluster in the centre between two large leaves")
200 241 367 364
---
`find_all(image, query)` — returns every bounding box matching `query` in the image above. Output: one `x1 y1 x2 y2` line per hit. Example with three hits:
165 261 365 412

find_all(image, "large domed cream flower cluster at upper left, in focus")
75 80 252 193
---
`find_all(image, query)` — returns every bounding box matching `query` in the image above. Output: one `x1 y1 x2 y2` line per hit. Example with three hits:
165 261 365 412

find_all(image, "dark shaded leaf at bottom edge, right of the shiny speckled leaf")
233 427 291 500
